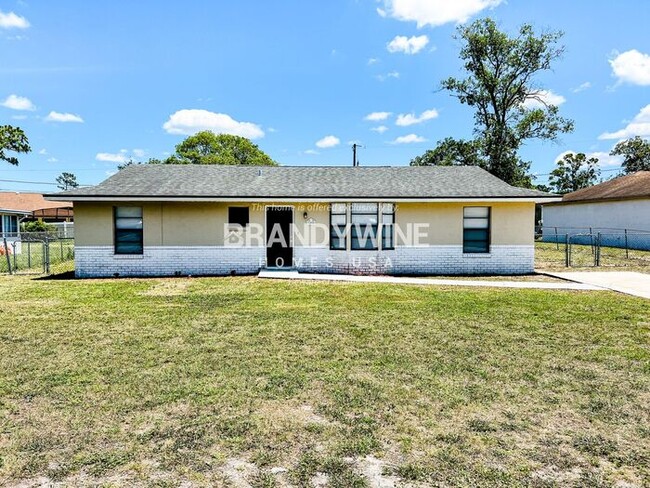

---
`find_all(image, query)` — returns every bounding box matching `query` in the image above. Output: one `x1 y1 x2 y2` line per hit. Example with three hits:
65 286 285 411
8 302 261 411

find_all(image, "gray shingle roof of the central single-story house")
48 164 552 200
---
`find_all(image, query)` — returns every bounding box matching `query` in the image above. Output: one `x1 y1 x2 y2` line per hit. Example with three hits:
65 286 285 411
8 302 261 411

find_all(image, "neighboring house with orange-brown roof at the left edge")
0 192 74 237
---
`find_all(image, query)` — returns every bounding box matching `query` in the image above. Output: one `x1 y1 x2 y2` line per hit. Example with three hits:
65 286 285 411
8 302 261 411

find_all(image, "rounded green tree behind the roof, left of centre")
164 131 278 166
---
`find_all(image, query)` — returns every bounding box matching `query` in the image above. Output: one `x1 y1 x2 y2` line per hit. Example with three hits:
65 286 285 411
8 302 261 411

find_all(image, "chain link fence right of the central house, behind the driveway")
535 227 650 271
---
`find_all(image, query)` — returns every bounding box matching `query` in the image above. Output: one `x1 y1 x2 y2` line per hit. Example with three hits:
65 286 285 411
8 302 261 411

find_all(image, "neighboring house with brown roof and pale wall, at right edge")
542 171 650 249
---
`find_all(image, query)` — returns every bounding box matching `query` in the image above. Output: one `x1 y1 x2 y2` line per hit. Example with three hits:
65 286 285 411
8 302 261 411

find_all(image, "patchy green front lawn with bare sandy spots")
0 276 650 487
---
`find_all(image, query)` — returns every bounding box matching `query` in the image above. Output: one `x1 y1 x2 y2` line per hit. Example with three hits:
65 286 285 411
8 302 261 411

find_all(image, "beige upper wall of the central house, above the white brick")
74 202 535 250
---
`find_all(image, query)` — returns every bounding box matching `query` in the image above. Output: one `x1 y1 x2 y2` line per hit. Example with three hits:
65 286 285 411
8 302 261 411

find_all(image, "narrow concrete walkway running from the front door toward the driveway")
258 270 603 290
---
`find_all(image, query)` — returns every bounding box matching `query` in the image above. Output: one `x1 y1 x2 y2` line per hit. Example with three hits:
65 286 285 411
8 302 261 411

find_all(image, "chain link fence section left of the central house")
0 232 74 274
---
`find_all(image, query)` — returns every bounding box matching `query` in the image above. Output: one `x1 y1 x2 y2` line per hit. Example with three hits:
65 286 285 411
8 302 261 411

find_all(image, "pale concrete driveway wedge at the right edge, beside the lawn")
544 271 650 298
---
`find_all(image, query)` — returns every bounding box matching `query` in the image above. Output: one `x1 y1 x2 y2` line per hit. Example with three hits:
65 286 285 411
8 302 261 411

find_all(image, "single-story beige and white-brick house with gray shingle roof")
46 165 555 277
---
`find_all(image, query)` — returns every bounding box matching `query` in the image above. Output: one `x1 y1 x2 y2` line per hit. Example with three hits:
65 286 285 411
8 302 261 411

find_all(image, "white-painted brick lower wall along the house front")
75 246 535 278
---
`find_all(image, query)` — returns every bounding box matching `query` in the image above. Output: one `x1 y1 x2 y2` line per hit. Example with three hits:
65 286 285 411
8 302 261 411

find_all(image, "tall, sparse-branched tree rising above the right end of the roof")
442 19 573 186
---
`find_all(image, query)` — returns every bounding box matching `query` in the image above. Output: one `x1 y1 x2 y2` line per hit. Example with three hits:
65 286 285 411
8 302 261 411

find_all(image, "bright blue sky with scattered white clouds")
0 0 650 191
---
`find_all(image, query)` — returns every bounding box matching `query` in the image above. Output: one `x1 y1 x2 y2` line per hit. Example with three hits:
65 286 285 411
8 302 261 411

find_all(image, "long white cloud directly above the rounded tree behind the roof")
163 109 264 139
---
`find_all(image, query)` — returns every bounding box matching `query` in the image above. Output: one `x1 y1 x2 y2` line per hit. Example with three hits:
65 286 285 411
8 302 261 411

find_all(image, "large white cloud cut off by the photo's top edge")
377 0 503 27
